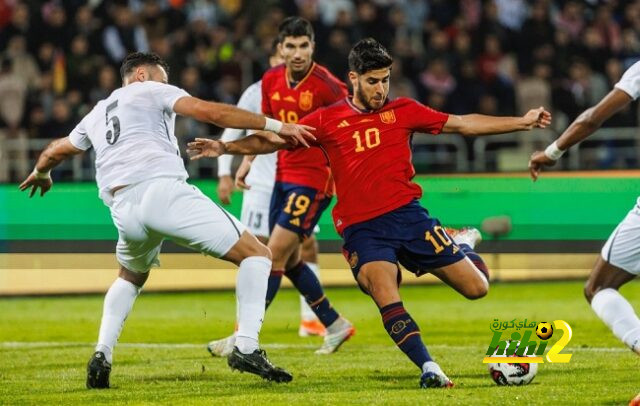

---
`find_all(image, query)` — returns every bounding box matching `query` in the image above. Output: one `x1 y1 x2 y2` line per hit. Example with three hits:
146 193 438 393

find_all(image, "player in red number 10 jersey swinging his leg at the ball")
190 38 551 388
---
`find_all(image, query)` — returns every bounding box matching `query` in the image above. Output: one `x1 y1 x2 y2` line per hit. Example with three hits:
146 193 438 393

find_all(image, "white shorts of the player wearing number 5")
111 178 245 272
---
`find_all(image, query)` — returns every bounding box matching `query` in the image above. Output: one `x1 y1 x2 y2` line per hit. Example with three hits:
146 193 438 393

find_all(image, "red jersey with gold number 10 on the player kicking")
300 98 449 234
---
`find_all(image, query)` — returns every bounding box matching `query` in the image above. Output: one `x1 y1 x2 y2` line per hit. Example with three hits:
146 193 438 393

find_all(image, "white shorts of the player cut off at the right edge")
600 205 640 275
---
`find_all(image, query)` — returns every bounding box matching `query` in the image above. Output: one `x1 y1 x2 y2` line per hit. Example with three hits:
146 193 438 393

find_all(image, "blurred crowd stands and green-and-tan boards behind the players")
0 0 640 294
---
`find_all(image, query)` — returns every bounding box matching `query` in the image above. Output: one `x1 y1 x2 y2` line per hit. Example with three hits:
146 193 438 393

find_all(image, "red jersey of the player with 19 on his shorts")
262 63 348 194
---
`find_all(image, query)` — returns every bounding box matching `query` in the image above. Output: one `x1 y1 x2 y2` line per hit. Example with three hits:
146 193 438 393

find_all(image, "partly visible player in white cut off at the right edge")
529 62 640 364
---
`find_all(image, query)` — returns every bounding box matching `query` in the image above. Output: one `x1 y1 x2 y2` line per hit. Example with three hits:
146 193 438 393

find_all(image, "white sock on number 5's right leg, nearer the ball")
235 257 271 354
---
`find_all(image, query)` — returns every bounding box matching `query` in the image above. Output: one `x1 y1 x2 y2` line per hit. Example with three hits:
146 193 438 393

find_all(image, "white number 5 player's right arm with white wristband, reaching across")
173 96 315 147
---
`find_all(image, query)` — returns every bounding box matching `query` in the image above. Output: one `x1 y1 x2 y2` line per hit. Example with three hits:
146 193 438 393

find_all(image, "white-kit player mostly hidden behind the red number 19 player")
212 43 325 357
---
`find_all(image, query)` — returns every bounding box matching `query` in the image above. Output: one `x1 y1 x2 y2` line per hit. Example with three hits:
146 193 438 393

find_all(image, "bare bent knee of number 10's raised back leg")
431 256 489 299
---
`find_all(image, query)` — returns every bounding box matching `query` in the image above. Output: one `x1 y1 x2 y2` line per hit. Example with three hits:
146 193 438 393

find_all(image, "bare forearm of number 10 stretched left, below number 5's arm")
187 131 292 160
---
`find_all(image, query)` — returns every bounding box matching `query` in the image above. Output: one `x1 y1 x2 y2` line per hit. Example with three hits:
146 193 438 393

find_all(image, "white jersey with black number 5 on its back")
69 81 189 206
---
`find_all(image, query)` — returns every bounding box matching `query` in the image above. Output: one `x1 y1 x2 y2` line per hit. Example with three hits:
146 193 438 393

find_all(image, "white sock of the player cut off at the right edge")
591 288 640 355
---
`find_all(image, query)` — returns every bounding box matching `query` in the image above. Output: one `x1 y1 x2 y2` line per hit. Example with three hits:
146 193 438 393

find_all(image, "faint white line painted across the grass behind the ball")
0 341 629 353
